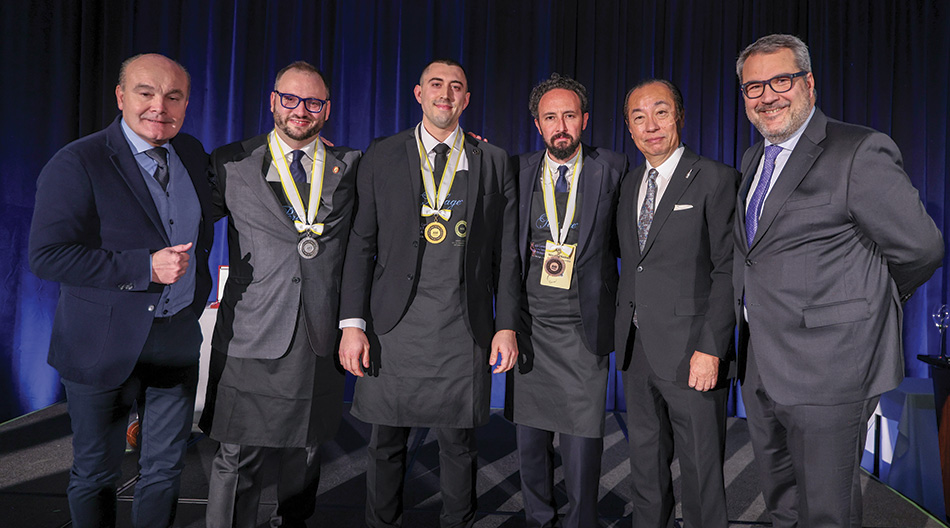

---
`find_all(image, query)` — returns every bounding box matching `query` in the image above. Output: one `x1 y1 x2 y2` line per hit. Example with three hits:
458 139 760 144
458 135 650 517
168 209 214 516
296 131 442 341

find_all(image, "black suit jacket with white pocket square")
616 147 739 382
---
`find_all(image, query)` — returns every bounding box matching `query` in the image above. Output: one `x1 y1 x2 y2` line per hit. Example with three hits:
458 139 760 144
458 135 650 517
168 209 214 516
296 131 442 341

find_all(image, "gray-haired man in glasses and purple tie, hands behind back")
733 35 944 527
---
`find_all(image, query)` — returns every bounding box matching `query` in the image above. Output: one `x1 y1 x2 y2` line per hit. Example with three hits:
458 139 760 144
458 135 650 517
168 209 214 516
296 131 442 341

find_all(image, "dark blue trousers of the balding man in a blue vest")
63 308 201 528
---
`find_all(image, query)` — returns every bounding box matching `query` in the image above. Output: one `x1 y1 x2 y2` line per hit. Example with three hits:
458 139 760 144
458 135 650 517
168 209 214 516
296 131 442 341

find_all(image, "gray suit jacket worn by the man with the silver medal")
211 134 360 359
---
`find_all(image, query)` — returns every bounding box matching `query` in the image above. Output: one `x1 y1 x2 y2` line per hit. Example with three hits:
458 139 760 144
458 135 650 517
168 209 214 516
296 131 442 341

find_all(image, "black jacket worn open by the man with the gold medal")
340 129 521 348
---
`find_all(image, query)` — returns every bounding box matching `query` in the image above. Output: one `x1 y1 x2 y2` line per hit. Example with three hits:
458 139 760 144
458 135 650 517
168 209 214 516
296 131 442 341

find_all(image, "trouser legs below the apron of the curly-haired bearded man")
517 425 604 528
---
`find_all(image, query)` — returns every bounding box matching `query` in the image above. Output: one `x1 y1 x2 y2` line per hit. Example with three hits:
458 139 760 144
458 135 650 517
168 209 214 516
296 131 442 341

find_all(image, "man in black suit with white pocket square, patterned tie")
616 79 738 528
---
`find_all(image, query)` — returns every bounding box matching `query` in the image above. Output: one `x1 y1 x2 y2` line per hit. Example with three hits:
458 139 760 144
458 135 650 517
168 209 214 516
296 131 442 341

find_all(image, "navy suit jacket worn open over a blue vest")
30 118 214 386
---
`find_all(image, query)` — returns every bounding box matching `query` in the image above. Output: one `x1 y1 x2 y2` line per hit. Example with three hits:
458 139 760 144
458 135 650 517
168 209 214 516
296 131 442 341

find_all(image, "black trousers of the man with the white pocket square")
623 336 729 528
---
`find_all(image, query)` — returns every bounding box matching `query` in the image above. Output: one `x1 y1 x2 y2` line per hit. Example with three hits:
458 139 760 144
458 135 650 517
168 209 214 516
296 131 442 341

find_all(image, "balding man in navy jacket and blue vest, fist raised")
29 54 213 527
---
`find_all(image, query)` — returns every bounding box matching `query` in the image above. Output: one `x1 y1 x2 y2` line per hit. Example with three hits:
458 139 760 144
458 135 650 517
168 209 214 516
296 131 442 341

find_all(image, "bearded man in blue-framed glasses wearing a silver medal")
201 61 360 528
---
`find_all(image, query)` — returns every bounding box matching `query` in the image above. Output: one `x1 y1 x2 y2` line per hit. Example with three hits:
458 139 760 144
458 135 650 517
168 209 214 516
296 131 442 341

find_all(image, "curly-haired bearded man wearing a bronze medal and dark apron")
508 73 627 527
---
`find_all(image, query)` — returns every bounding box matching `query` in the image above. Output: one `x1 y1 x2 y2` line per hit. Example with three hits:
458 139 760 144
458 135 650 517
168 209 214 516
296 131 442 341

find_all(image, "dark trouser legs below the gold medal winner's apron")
366 424 478 528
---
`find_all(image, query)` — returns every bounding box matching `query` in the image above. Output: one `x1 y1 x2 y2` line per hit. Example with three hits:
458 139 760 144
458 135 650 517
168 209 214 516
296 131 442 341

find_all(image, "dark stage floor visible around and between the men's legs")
0 404 945 528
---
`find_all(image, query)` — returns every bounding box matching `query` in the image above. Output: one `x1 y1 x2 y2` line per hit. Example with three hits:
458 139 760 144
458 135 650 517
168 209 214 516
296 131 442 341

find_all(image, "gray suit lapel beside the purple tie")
742 108 828 251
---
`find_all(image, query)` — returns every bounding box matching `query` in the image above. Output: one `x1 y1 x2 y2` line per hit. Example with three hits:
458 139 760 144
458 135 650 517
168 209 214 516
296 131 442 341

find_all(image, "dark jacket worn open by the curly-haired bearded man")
518 145 627 356
